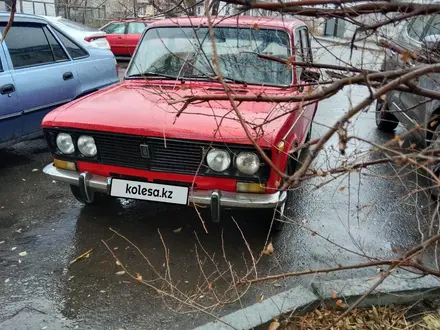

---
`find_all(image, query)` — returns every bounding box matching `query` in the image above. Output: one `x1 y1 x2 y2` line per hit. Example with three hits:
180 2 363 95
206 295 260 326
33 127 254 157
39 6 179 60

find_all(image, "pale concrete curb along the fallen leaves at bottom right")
193 271 440 330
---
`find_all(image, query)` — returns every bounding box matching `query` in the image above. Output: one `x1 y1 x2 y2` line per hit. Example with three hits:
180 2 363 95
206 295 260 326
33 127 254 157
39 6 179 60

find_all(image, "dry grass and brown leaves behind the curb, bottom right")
278 307 440 330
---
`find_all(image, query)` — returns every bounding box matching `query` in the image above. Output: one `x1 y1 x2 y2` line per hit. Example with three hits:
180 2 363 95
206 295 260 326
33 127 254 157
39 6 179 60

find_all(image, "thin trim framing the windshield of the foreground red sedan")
124 23 295 89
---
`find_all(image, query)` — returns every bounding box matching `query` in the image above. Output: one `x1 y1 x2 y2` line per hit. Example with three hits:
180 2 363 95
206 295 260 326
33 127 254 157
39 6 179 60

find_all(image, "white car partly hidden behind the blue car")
43 16 110 49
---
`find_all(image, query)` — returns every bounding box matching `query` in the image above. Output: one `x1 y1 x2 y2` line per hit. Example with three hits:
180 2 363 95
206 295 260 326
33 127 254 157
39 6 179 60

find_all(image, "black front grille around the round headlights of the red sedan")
45 129 270 182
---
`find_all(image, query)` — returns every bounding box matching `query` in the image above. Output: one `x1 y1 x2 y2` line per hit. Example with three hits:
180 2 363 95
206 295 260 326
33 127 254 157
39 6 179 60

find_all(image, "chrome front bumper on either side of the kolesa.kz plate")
43 163 287 209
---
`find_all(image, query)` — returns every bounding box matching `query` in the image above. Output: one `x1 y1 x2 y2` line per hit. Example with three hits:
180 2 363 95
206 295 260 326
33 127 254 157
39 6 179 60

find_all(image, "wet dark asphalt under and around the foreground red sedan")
0 43 435 329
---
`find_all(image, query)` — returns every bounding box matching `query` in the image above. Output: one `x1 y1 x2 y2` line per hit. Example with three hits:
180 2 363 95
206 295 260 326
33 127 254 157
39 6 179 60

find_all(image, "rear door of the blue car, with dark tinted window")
5 22 80 135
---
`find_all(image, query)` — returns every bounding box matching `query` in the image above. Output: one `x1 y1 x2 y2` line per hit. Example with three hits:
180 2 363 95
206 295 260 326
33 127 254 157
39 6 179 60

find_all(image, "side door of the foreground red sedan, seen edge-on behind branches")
294 26 315 142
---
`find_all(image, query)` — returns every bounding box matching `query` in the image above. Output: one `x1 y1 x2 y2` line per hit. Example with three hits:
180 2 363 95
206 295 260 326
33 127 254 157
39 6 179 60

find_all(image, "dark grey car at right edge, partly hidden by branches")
376 14 440 192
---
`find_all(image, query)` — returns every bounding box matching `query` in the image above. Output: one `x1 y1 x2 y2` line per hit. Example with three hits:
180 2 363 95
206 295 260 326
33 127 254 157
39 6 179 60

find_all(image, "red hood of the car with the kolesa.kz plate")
43 82 297 145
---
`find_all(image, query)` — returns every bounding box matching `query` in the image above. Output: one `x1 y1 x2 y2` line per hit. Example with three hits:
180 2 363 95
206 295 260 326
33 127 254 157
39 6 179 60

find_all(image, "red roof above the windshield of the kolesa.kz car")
149 16 306 30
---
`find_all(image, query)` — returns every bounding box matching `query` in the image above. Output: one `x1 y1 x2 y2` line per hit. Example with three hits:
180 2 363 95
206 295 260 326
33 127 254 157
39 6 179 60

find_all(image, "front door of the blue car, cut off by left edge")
0 38 21 146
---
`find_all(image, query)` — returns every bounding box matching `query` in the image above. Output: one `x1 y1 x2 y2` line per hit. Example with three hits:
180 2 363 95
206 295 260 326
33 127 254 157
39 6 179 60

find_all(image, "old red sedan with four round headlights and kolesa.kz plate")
42 17 319 229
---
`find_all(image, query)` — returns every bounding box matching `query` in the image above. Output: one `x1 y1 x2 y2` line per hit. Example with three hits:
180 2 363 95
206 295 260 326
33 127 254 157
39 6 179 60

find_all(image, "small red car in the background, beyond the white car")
100 19 151 56
